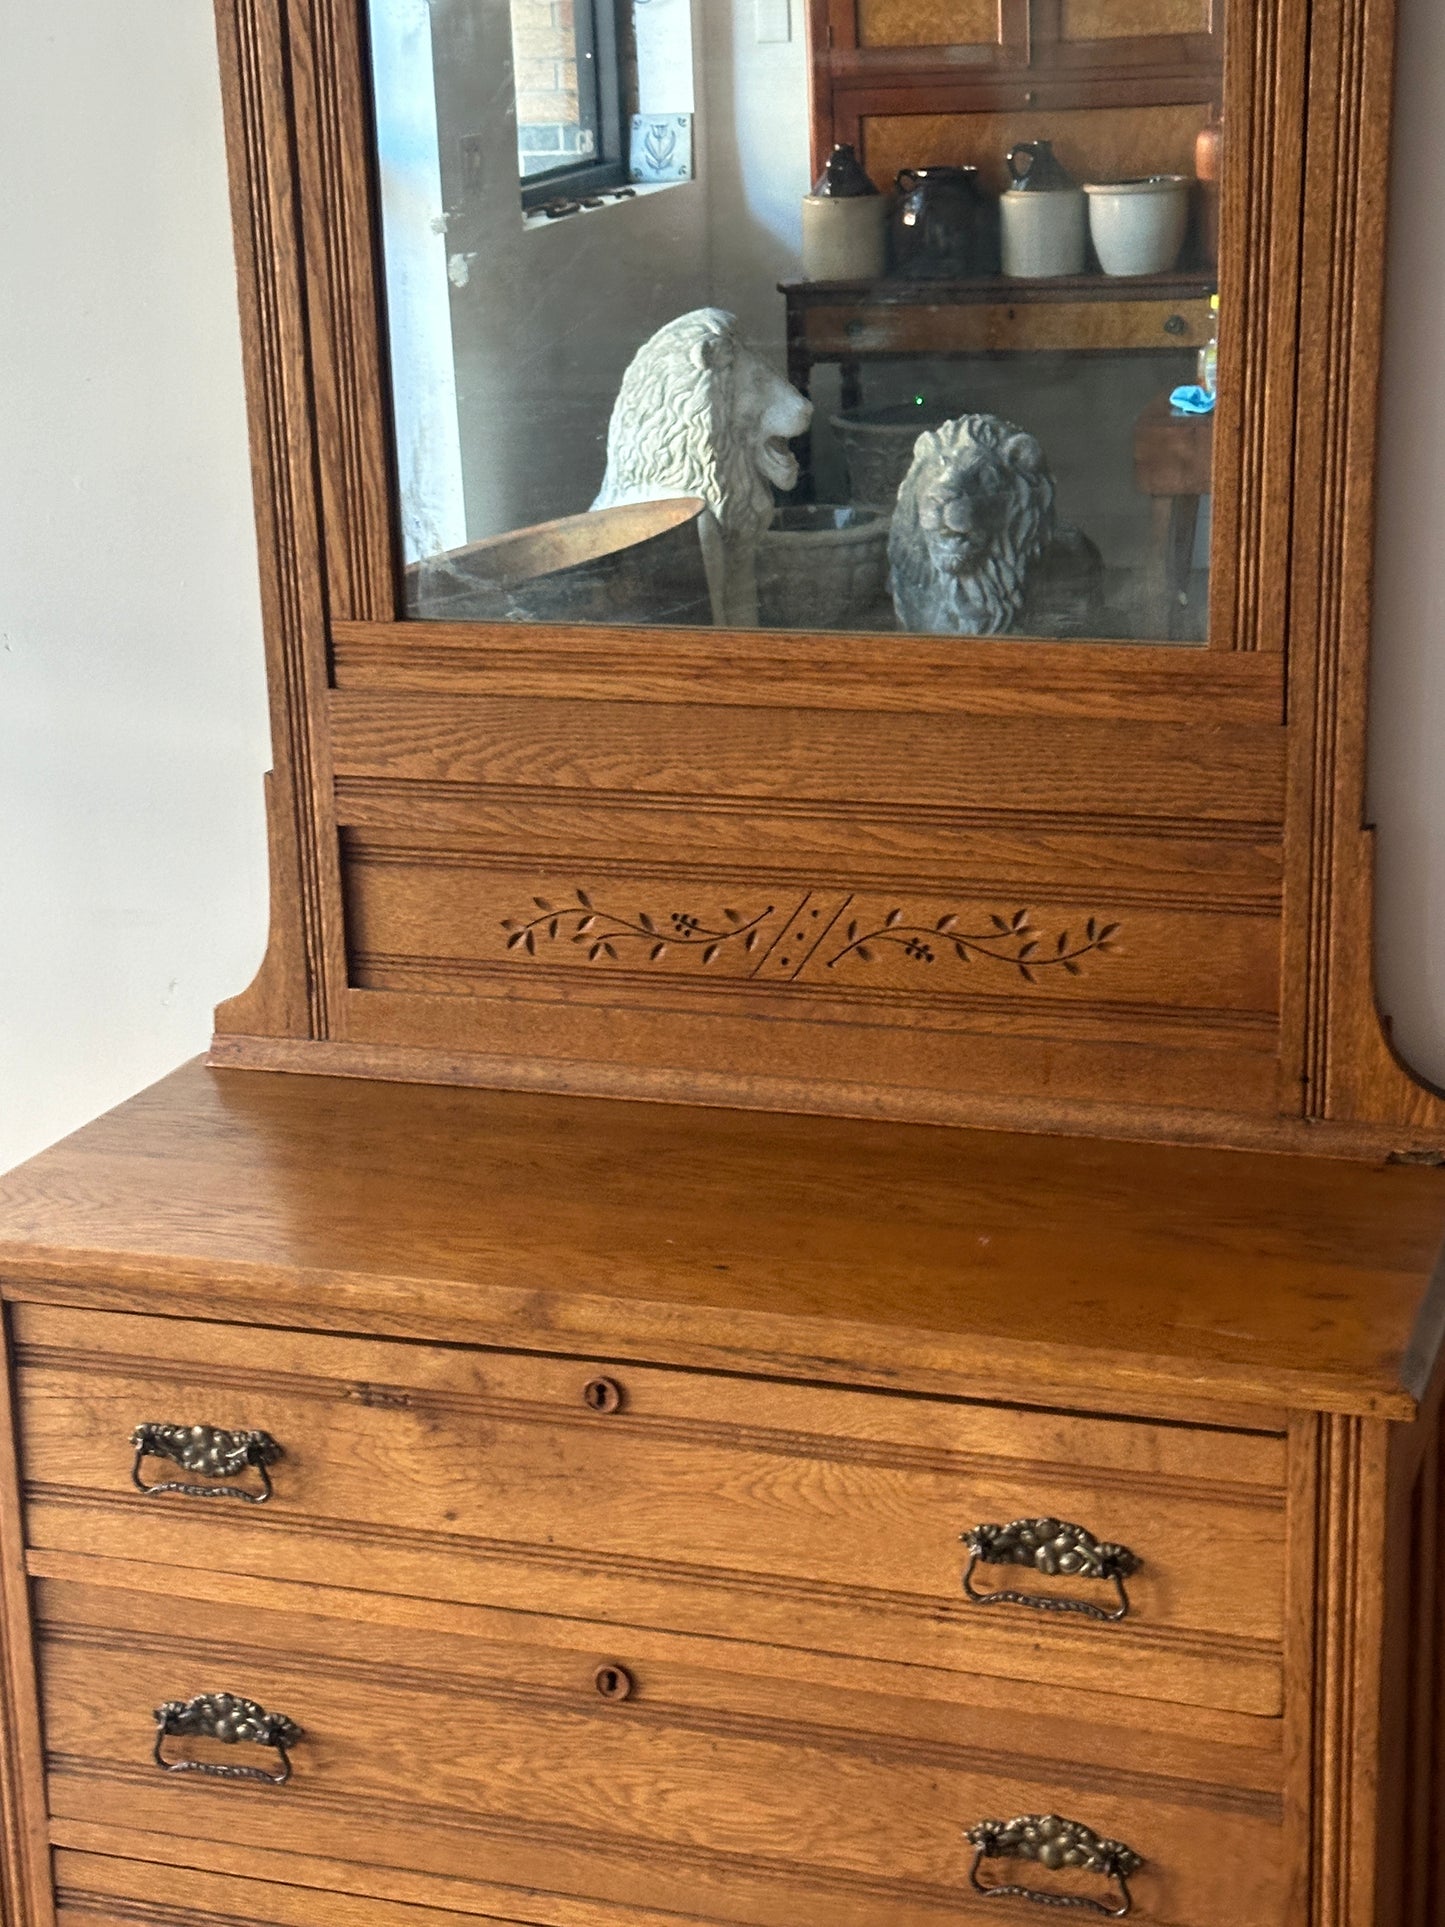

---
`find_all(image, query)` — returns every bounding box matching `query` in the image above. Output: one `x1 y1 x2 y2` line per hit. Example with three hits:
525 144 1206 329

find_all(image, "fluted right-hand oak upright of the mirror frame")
1281 0 1445 1139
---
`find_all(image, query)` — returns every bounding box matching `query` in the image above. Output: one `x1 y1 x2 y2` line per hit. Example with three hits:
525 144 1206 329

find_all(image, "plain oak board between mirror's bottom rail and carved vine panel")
329 690 1285 825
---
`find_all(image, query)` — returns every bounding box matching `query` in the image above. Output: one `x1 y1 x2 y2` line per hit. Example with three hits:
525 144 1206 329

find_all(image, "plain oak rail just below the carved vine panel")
333 971 1279 1117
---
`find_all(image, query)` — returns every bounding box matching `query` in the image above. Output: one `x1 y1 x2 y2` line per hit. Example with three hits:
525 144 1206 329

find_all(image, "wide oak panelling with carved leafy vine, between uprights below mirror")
319 659 1283 1116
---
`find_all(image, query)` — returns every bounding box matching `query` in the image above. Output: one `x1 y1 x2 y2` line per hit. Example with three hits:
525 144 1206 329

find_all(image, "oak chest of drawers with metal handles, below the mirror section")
0 1066 1445 1927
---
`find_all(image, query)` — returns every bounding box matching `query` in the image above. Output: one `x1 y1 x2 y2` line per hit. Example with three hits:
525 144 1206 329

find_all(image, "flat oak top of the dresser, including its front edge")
0 1064 1445 1416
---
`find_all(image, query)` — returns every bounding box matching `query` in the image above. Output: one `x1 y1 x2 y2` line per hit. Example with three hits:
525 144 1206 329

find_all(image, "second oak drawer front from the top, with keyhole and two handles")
35 1578 1287 1927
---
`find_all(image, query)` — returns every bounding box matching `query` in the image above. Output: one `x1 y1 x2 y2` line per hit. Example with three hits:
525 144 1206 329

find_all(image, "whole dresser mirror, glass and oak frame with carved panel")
214 0 1445 1150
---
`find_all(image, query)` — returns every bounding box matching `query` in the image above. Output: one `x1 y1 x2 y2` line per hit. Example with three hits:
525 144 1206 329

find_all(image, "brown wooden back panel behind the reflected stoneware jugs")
863 98 1214 193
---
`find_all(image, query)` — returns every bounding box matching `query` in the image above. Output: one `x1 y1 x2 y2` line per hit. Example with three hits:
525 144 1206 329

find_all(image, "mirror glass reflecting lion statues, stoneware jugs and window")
370 0 1223 642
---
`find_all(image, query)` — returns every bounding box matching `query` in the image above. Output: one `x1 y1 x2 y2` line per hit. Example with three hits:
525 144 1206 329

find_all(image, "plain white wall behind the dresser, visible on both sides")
0 0 1445 1168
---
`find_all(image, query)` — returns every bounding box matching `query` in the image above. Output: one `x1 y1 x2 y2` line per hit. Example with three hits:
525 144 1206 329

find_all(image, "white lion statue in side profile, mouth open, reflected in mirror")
591 308 813 628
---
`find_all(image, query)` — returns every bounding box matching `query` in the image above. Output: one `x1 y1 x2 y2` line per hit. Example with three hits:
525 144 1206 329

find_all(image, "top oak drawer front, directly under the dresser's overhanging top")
12 1307 1285 1713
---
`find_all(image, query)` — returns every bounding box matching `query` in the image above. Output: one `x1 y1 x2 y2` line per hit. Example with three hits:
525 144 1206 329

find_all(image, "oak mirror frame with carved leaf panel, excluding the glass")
212 0 1445 1158
